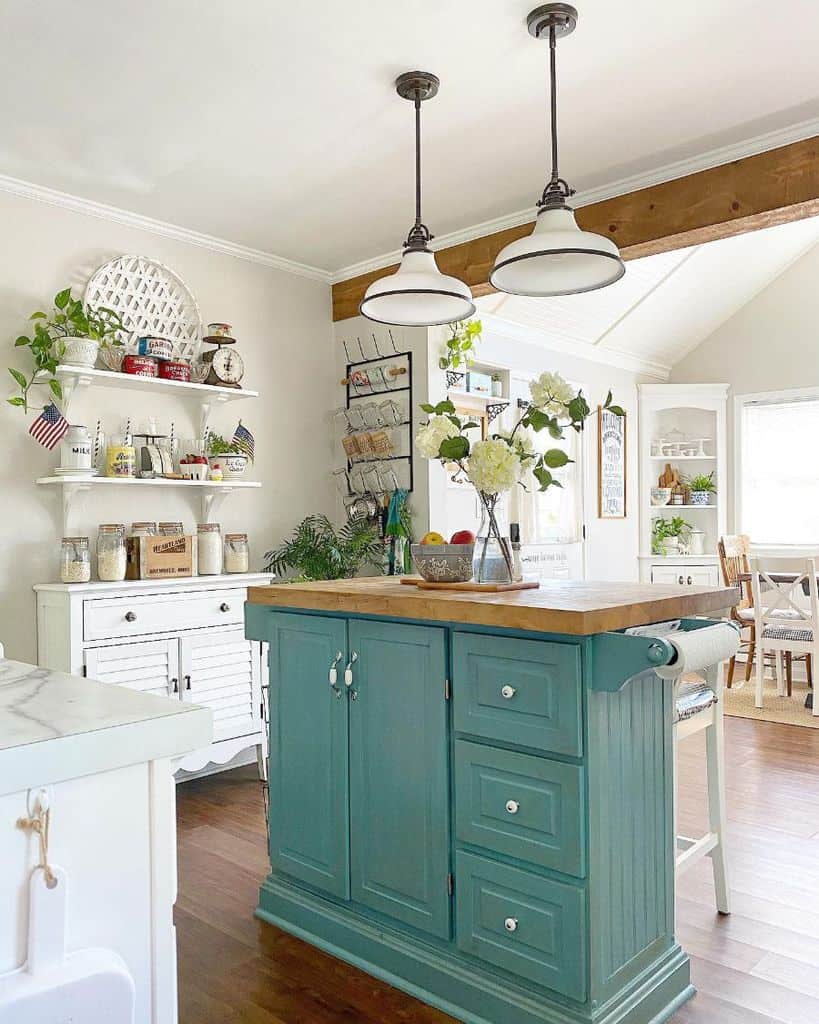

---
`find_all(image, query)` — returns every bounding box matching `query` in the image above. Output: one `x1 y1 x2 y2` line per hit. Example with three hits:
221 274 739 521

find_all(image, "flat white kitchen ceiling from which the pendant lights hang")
0 0 819 270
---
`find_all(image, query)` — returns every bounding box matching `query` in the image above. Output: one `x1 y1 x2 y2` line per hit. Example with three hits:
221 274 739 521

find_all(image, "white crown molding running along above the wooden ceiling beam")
331 118 819 285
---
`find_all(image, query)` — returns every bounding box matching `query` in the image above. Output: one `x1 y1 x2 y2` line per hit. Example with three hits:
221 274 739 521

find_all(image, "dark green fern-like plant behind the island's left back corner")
264 515 384 581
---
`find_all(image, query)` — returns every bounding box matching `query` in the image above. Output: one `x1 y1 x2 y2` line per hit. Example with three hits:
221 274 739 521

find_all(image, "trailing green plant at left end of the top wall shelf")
7 288 125 413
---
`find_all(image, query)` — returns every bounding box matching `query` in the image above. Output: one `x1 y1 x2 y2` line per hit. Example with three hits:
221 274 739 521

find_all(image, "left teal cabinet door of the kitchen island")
268 612 350 899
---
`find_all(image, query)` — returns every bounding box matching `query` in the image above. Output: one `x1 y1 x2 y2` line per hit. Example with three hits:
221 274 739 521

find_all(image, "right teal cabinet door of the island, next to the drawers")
348 621 450 938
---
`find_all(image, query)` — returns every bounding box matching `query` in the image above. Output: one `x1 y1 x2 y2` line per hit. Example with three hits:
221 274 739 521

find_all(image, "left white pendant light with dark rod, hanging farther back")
359 71 475 327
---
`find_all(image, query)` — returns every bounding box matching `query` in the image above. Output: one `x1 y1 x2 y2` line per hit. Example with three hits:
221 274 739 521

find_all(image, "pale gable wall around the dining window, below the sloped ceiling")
671 236 819 530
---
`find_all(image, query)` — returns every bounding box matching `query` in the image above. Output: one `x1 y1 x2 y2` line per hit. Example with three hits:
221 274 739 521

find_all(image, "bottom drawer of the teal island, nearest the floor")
456 852 586 1002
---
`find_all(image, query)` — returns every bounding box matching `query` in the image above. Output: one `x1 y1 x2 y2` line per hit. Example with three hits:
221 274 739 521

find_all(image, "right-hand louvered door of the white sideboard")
179 627 261 742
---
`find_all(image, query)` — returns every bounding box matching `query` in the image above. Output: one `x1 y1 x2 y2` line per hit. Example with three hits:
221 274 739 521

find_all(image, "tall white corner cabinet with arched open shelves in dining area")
638 384 728 587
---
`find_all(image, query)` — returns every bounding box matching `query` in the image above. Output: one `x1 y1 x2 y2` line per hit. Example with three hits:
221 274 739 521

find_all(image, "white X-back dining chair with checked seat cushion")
751 558 819 715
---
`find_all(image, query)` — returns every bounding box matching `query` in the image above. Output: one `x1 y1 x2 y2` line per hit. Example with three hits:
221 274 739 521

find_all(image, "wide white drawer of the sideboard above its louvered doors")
83 588 247 640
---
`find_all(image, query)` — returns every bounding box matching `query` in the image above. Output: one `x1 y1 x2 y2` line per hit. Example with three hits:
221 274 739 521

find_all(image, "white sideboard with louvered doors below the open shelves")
34 572 271 772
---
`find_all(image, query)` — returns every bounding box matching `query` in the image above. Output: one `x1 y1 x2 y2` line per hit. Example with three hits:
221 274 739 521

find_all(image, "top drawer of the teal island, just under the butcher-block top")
452 633 583 757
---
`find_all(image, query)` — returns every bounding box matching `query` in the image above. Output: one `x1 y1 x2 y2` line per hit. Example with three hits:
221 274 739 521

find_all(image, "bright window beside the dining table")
736 390 819 546
